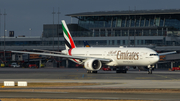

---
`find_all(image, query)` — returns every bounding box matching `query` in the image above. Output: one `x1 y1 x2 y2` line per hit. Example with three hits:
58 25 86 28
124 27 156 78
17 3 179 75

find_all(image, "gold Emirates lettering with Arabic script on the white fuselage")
108 50 139 60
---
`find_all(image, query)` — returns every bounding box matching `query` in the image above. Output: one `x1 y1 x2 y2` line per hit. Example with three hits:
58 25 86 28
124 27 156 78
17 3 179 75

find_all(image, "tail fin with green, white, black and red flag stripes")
62 20 76 49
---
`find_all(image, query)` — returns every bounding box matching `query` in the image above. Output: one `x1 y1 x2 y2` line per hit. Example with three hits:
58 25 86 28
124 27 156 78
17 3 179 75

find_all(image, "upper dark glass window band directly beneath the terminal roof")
78 14 180 30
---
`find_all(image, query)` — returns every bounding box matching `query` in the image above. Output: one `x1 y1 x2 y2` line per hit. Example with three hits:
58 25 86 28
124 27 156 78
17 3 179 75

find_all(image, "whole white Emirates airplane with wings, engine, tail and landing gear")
12 20 176 74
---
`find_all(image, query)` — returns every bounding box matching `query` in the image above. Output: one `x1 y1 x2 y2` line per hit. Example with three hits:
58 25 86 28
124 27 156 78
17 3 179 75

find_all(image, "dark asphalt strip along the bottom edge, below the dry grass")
0 92 179 101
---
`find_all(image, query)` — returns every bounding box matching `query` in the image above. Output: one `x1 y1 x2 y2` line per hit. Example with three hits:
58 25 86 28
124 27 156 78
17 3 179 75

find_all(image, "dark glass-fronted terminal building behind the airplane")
0 9 180 67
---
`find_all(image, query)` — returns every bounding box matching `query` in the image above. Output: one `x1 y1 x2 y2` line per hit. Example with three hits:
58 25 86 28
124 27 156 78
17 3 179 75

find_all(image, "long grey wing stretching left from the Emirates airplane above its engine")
11 51 112 62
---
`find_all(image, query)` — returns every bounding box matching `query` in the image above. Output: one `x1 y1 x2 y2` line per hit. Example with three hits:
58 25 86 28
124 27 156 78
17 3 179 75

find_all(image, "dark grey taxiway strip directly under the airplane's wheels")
0 68 180 80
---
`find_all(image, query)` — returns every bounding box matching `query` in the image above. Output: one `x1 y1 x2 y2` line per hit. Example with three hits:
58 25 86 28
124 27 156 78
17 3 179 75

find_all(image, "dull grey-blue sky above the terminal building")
0 0 180 36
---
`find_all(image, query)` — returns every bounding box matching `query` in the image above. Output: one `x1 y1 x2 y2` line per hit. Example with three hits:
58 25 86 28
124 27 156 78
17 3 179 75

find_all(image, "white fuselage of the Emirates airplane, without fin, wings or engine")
62 47 159 66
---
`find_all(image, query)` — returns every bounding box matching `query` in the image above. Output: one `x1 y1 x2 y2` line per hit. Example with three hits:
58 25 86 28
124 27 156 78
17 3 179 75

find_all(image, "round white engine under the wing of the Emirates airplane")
84 59 102 71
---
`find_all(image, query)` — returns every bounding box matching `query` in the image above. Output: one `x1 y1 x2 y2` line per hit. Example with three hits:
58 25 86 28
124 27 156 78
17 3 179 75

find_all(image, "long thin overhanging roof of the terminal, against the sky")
66 9 180 17
